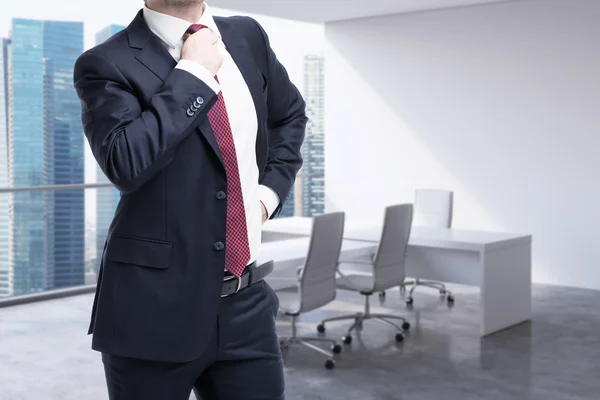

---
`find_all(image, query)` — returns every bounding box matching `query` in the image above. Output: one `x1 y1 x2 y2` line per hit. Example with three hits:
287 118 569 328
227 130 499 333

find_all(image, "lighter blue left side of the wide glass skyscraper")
9 19 46 295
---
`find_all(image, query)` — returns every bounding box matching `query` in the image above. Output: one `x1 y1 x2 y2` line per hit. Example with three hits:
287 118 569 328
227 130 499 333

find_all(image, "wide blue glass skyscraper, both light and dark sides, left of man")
8 19 84 295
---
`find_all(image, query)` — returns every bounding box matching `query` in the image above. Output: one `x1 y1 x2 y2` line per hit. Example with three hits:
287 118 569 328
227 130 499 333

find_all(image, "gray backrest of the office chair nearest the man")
298 212 345 313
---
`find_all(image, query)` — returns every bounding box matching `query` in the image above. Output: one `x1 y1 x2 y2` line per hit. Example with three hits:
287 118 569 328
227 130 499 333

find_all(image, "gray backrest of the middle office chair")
373 204 413 292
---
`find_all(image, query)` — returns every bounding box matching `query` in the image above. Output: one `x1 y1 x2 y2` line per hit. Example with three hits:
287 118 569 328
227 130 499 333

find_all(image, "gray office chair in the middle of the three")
317 204 413 344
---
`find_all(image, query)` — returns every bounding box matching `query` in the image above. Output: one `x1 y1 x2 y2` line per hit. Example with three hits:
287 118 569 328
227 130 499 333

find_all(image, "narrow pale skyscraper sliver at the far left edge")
0 38 13 298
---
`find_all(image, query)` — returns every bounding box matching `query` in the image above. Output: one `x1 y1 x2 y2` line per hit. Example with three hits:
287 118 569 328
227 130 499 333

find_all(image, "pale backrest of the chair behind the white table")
413 189 454 228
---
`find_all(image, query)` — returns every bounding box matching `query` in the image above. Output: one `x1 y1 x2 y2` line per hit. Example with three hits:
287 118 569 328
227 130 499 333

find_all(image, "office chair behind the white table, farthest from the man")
400 189 454 305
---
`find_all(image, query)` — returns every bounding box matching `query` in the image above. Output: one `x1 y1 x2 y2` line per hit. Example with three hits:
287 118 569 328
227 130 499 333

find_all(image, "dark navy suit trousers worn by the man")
102 281 284 400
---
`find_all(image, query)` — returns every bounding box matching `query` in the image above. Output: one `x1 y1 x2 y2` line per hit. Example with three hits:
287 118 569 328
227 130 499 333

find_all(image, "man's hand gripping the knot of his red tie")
181 28 223 75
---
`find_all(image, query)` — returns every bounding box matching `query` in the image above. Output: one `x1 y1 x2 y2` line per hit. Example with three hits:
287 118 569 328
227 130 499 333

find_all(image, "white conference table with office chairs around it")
263 217 531 336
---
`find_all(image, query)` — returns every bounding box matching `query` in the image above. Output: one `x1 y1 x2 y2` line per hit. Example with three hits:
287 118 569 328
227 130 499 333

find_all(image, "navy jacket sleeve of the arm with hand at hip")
247 19 308 218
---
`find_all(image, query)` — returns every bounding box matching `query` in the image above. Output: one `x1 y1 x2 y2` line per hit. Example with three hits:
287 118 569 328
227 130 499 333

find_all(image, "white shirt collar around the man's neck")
143 3 221 48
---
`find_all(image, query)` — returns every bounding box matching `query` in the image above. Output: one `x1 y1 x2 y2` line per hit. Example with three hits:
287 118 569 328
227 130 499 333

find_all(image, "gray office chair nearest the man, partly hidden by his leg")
277 212 344 369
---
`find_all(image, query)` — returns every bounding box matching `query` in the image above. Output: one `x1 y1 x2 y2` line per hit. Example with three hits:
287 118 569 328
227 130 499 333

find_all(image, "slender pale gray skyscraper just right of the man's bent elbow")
296 55 325 217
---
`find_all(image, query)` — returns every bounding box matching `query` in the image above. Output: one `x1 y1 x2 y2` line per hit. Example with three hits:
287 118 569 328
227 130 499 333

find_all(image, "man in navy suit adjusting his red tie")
74 0 307 400
